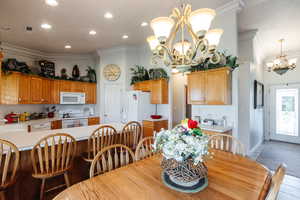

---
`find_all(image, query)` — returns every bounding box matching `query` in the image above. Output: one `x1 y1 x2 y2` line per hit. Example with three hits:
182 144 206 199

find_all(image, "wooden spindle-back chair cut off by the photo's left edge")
0 139 20 200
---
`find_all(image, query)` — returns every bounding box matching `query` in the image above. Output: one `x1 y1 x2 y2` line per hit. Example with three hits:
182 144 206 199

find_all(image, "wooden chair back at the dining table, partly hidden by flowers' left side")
135 137 156 160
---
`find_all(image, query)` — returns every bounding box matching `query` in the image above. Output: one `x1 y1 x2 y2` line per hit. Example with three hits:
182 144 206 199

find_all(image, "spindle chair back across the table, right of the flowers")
208 134 245 156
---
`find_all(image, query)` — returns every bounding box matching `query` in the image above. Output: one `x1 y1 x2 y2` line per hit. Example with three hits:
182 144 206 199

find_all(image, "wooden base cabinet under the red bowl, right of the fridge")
143 120 168 137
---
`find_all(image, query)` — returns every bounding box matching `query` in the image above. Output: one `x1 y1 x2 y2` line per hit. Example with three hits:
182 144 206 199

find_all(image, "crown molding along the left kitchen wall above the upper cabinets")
1 42 97 61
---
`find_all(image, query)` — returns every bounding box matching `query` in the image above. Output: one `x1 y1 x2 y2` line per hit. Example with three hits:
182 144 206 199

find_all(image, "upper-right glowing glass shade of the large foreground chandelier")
188 8 216 38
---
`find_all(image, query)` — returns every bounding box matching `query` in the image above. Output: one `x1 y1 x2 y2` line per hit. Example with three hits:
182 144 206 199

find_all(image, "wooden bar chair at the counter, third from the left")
82 125 119 163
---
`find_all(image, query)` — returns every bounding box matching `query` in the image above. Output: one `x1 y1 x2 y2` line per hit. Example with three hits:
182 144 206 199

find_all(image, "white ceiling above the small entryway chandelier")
238 0 300 58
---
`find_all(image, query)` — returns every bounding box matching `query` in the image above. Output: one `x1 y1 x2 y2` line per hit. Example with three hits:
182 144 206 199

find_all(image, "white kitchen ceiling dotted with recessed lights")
0 0 230 53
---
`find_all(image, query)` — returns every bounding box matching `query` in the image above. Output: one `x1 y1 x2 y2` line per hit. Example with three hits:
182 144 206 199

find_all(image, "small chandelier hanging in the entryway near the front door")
266 39 297 75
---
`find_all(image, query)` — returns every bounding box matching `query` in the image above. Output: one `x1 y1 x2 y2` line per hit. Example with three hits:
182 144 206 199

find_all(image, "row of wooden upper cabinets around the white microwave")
0 72 97 104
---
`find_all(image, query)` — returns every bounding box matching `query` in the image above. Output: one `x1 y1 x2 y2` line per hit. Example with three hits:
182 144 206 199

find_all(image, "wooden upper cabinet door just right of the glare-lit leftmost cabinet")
19 75 31 104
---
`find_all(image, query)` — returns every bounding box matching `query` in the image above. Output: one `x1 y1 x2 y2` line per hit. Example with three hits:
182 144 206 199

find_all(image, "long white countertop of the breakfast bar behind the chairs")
0 123 125 151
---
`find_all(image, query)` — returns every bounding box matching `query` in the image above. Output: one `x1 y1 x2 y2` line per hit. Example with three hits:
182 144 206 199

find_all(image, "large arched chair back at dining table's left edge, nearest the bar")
90 144 135 178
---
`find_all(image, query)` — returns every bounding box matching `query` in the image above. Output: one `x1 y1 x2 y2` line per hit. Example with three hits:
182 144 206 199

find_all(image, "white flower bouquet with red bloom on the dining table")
153 120 209 165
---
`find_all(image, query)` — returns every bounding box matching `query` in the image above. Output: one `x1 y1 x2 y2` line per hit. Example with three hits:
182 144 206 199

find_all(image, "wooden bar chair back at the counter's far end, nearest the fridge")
121 121 142 149
